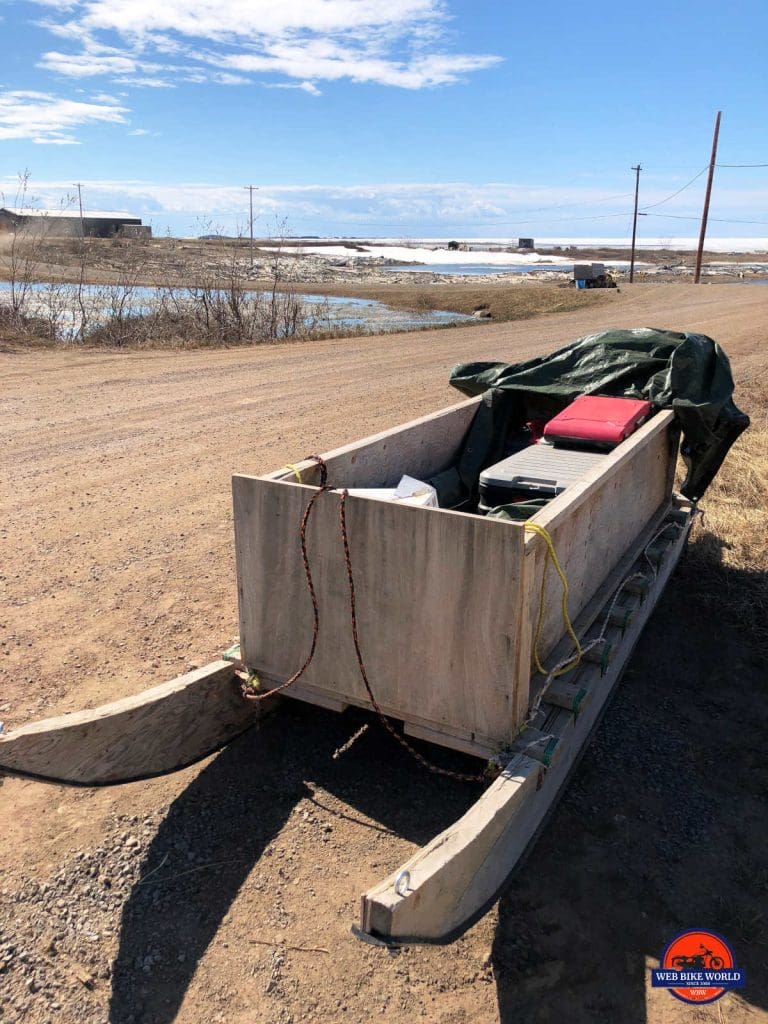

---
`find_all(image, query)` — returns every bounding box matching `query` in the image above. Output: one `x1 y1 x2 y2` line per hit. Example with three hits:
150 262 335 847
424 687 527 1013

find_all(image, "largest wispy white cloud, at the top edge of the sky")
30 0 501 95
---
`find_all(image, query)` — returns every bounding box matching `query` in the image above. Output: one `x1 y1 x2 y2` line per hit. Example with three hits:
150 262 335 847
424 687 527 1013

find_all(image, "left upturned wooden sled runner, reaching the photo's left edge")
0 662 260 785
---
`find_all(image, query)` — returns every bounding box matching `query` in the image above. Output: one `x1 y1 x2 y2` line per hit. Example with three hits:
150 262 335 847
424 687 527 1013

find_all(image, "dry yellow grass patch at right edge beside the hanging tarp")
685 381 768 653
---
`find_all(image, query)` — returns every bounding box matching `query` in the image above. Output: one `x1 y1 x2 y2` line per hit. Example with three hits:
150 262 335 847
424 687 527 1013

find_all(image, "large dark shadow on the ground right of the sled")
493 558 768 1024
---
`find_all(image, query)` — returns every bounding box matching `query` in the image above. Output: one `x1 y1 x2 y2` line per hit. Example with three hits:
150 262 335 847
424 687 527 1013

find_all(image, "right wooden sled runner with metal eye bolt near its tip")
360 512 689 942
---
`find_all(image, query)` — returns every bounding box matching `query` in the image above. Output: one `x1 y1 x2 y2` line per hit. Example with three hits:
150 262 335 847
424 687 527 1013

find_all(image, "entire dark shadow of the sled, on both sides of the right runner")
110 544 768 1024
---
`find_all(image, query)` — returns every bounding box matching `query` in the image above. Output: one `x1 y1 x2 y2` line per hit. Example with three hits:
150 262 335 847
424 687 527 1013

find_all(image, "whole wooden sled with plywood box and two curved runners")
0 399 692 942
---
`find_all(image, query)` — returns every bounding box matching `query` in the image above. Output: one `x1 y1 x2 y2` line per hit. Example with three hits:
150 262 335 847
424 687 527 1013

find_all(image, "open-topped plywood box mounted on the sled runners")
232 398 677 757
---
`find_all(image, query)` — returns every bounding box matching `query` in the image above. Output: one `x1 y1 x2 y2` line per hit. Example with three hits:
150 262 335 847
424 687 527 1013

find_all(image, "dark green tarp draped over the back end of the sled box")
432 328 750 505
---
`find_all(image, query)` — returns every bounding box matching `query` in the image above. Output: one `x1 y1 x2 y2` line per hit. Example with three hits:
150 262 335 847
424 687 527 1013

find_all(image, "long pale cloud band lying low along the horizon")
0 177 768 237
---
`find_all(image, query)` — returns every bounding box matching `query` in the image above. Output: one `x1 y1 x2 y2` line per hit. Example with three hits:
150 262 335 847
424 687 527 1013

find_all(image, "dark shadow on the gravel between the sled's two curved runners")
109 700 480 1024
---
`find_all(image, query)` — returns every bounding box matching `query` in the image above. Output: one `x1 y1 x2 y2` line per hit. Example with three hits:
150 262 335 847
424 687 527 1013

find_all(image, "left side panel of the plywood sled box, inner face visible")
262 397 480 487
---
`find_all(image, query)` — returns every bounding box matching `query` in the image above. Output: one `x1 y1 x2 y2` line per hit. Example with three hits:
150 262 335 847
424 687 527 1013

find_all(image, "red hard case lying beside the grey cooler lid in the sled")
544 394 650 447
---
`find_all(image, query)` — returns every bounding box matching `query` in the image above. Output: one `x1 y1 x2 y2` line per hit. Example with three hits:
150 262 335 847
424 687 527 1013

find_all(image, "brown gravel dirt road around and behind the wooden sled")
0 285 768 1024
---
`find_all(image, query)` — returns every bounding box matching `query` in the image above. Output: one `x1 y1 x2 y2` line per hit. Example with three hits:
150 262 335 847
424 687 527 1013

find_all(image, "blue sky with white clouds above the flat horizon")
0 0 768 238
